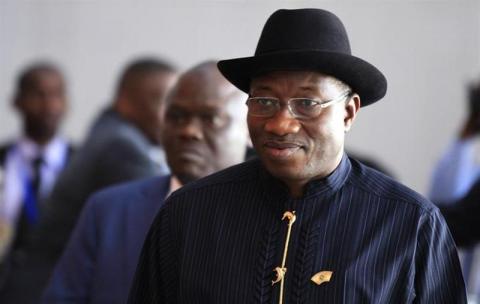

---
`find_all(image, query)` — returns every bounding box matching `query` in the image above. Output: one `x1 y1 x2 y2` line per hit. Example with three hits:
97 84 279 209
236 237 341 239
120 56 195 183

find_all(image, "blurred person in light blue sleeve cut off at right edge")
429 81 480 299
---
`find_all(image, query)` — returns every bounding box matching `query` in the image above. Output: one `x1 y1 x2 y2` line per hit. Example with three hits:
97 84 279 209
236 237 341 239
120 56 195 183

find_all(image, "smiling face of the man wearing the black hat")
248 71 359 185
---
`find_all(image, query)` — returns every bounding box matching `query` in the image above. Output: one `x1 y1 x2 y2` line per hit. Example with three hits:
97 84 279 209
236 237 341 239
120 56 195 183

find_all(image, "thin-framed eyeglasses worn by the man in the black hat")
245 90 353 119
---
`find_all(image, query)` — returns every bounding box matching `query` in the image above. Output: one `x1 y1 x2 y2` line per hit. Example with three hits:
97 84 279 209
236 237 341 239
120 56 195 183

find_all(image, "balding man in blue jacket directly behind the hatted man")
43 61 249 304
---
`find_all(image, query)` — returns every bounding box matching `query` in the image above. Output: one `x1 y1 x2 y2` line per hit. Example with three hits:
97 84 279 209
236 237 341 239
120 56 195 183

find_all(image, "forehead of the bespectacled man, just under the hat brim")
250 71 337 93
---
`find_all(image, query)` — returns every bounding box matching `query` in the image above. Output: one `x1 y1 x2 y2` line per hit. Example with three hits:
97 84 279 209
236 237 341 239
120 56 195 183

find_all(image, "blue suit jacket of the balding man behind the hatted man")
43 176 170 304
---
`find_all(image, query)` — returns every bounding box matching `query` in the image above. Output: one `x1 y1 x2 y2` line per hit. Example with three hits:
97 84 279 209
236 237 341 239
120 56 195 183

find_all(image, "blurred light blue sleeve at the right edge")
429 140 480 203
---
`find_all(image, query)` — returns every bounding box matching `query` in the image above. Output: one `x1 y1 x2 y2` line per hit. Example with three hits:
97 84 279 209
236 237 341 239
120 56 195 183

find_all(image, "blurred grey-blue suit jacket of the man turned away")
0 110 168 303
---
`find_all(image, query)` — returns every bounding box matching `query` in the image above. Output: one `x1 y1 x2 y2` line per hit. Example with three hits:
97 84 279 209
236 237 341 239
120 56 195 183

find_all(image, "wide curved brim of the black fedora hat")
218 50 387 107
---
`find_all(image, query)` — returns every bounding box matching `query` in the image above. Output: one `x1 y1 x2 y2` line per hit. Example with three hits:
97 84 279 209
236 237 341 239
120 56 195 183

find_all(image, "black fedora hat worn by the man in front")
218 9 387 106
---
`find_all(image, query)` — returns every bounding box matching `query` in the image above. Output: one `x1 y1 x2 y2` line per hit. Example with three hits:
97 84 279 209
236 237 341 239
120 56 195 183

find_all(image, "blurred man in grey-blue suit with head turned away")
0 58 176 303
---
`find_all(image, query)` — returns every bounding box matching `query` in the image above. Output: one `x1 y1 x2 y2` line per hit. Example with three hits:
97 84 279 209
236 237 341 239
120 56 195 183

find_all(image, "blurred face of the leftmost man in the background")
15 70 67 138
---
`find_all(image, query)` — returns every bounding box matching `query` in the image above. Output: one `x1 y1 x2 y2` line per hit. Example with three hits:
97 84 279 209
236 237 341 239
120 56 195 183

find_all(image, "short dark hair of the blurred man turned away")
117 58 176 92
